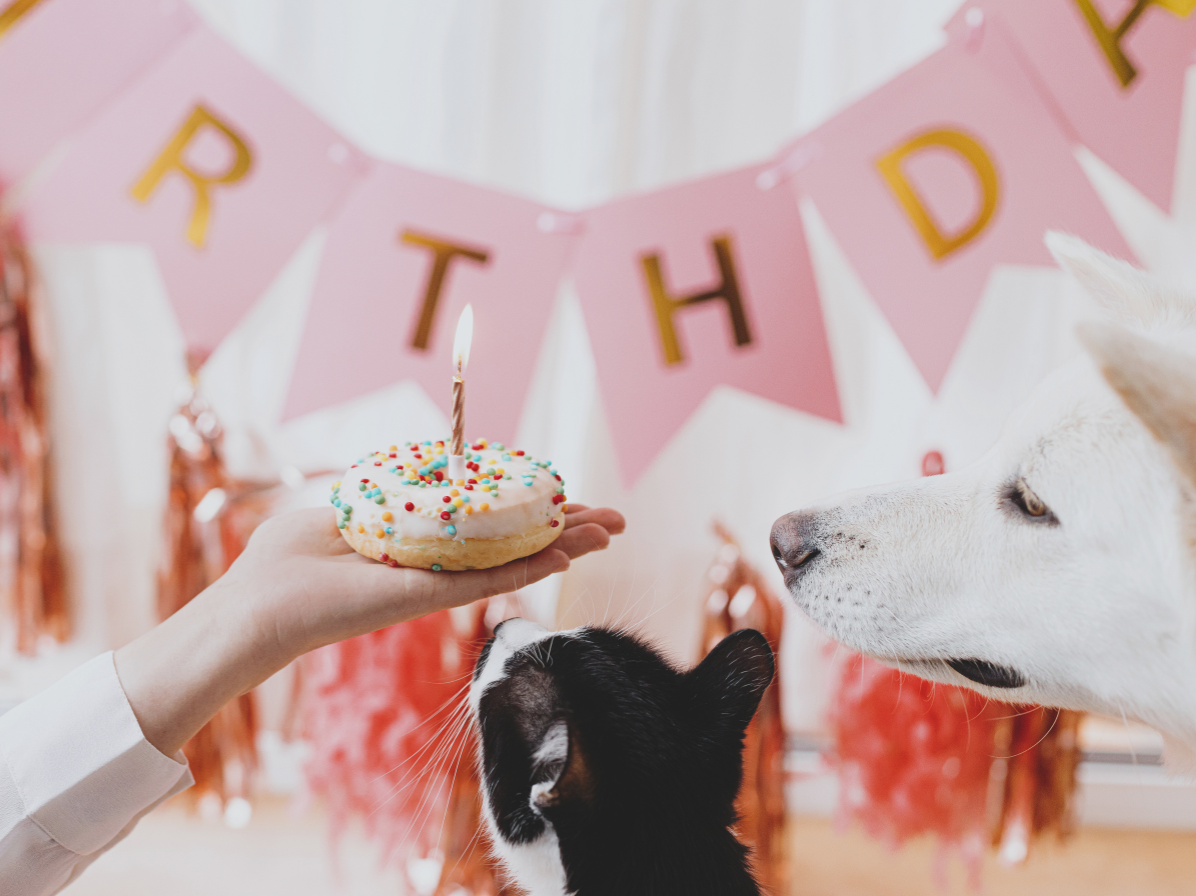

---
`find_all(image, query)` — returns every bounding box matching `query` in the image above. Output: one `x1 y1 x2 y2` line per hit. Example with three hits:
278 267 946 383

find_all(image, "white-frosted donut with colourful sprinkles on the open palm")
331 439 566 569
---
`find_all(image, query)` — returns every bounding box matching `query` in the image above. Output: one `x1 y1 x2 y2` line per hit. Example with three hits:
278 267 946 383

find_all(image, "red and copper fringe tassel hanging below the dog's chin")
828 654 1084 884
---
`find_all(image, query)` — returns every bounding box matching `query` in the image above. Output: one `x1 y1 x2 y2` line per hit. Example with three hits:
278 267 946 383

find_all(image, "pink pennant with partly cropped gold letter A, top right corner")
947 0 1196 211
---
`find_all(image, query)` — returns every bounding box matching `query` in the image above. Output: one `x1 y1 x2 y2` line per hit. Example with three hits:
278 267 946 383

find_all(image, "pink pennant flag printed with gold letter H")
573 166 841 484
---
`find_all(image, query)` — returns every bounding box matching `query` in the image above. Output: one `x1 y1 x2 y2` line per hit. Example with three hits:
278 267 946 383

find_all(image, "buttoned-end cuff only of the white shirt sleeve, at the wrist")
0 651 191 855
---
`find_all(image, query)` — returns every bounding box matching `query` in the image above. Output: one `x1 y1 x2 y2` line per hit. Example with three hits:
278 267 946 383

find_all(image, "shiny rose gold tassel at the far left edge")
0 216 71 654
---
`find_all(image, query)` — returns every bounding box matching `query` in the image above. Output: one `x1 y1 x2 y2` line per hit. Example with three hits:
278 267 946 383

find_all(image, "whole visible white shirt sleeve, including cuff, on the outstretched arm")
0 652 194 896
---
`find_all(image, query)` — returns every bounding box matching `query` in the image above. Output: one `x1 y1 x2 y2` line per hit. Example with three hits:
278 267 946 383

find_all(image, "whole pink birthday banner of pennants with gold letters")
0 0 1196 483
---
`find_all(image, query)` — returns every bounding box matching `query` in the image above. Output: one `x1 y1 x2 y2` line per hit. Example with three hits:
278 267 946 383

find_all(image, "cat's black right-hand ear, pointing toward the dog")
689 628 776 738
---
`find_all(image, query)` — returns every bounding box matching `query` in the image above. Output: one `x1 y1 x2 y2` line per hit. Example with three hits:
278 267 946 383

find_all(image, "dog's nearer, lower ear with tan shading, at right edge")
1076 323 1196 487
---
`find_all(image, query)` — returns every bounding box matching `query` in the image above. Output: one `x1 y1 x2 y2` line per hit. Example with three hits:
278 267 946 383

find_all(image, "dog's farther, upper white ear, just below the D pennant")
1047 231 1196 325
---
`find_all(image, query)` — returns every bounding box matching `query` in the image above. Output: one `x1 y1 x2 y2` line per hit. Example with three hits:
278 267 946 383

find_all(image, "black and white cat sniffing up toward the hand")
470 618 774 896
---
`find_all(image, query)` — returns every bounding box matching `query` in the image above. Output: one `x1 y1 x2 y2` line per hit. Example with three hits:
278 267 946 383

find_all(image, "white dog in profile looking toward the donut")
771 234 1196 768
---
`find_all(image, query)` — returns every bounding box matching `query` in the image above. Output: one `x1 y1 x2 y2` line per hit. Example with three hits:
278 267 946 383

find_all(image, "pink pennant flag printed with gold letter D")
794 30 1133 392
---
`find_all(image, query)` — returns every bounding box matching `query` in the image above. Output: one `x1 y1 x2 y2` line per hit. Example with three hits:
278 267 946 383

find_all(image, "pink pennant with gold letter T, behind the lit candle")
283 163 575 439
